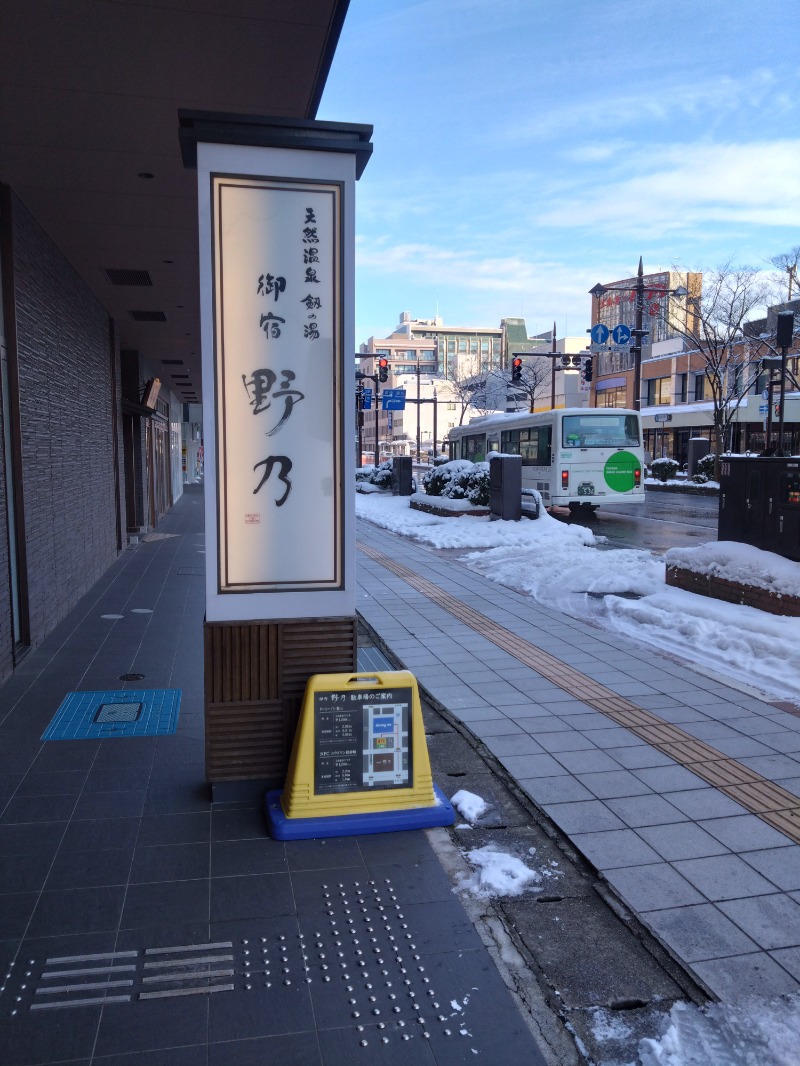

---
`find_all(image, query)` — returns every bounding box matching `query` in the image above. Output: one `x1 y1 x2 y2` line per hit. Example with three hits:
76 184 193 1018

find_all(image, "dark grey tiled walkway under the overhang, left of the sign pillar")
0 488 544 1066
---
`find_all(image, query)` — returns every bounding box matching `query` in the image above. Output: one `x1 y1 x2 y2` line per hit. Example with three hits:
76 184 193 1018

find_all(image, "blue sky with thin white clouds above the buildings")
318 0 800 343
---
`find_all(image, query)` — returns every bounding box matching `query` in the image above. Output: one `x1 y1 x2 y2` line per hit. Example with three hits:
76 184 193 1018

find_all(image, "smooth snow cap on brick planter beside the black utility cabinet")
665 540 800 596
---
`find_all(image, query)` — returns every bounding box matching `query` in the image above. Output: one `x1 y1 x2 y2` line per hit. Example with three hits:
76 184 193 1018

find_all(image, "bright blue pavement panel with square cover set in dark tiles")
42 689 180 740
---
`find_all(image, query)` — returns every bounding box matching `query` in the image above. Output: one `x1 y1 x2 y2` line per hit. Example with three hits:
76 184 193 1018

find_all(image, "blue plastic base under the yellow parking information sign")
266 785 455 840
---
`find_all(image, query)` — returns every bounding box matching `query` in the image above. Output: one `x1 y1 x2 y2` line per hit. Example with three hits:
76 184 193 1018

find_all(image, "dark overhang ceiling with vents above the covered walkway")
0 0 349 400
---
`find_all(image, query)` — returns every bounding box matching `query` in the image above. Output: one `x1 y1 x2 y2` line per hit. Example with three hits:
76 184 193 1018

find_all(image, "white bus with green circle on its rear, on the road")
448 407 644 511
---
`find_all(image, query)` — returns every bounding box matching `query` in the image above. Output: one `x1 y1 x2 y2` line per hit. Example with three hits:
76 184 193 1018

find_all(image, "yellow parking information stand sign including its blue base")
267 671 454 840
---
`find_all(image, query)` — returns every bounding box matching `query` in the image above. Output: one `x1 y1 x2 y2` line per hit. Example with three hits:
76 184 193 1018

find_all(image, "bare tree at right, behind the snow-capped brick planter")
671 262 772 478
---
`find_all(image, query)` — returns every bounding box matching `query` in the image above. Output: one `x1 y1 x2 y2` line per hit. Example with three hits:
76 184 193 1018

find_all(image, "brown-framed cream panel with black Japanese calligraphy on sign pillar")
212 176 342 593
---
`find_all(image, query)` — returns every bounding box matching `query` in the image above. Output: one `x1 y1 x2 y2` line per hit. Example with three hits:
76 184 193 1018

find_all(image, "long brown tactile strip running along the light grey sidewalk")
358 542 800 843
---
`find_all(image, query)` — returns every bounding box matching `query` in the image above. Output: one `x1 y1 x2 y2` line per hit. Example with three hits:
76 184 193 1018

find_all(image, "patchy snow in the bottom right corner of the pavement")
639 995 800 1066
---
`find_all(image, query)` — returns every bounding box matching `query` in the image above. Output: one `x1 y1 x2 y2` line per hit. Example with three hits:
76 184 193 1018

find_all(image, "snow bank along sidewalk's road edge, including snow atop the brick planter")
356 495 800 699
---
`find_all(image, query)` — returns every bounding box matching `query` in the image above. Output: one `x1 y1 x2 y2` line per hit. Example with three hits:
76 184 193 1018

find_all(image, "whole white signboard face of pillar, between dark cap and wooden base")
198 145 354 620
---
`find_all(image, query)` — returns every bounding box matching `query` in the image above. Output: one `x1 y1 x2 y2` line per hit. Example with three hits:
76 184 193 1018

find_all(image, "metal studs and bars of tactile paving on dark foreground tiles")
0 871 507 1062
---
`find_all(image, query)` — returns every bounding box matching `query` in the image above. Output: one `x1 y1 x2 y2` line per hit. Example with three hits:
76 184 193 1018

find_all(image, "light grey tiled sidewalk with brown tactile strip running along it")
357 521 800 1001
